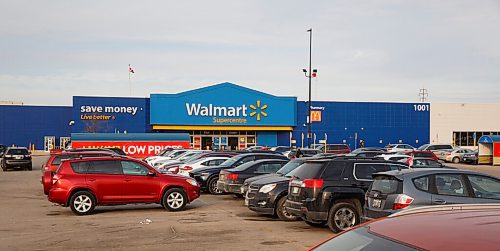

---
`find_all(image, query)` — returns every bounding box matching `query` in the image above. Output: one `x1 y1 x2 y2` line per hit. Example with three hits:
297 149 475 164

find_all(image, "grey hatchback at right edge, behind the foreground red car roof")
364 168 500 220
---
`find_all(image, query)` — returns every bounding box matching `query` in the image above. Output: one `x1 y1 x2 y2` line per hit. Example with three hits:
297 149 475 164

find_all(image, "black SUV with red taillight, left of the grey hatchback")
285 157 408 233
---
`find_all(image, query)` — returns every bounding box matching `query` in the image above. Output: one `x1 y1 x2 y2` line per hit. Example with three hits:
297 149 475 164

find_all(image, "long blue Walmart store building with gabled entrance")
0 83 430 149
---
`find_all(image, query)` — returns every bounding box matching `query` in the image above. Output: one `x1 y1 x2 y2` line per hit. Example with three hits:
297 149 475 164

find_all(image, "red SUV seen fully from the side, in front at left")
44 156 200 215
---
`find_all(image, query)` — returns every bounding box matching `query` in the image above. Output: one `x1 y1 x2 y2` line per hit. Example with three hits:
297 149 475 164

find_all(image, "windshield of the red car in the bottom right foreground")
313 227 418 251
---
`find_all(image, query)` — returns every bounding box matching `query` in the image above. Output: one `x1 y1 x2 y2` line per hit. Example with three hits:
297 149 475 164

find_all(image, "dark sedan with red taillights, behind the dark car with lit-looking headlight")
217 159 288 195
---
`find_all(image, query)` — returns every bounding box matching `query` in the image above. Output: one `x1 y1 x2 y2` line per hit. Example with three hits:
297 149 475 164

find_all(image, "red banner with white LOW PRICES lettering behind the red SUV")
71 141 189 158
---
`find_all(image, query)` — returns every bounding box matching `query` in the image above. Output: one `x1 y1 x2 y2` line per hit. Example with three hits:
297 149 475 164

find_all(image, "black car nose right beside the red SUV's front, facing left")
189 153 288 194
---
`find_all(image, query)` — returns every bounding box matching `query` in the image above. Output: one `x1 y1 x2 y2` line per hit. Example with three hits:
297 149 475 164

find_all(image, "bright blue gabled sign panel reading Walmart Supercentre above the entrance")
151 83 297 126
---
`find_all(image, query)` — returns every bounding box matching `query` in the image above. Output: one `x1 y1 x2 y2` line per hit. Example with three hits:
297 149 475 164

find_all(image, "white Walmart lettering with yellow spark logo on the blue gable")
186 100 268 124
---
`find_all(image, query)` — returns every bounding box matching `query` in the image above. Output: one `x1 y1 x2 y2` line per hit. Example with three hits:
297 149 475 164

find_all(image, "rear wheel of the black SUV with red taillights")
328 202 359 233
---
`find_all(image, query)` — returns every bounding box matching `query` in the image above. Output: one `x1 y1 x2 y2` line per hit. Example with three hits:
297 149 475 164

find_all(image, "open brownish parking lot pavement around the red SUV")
0 156 332 250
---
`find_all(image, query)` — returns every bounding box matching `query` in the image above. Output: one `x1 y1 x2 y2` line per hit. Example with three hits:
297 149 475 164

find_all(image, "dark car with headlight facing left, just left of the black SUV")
243 158 324 221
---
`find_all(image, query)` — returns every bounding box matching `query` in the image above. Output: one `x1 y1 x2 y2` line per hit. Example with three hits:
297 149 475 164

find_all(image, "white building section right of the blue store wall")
429 103 500 148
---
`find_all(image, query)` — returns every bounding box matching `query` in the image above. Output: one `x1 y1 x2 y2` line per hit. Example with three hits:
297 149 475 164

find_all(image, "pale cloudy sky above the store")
0 0 500 105
